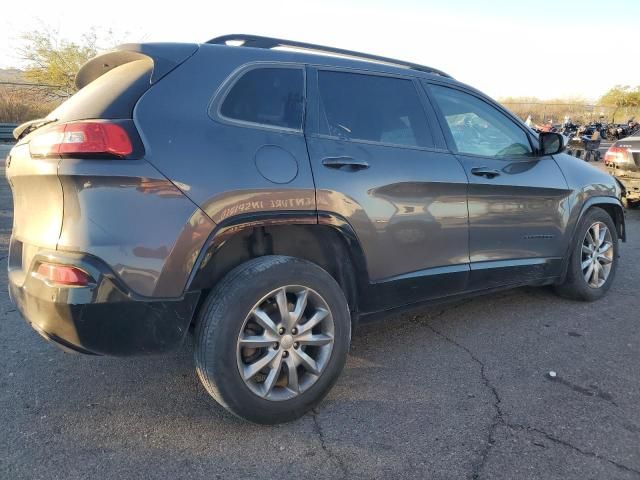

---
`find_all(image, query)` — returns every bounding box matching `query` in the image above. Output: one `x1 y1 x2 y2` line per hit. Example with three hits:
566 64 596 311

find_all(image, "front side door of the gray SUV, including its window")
428 84 570 289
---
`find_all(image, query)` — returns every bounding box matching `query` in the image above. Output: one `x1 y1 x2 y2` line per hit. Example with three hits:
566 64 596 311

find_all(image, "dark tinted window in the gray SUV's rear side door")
318 71 433 147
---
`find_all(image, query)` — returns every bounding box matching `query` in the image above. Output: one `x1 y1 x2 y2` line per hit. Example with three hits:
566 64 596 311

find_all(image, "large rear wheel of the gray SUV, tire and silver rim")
195 256 351 424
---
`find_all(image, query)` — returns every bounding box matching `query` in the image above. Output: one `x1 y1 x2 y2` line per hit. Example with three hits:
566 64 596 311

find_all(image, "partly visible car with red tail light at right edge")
604 133 640 208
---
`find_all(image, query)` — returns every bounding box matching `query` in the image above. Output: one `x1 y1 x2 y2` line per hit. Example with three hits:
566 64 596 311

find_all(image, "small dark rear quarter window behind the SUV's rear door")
220 68 304 130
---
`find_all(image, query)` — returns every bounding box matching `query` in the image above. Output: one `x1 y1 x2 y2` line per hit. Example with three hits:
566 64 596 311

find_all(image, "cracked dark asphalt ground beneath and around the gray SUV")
0 158 640 480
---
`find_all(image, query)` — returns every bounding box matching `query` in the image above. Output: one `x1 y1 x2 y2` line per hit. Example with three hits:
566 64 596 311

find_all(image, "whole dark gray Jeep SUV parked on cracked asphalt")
6 35 625 423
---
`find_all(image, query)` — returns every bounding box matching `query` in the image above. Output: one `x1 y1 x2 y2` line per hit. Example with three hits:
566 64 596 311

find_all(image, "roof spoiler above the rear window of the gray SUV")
76 43 199 89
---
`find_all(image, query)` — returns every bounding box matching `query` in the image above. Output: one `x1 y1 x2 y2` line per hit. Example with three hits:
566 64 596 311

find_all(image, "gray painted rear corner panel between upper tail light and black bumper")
58 159 214 297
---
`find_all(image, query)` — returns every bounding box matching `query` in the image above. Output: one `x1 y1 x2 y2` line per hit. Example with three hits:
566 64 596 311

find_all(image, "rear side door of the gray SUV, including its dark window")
305 67 469 311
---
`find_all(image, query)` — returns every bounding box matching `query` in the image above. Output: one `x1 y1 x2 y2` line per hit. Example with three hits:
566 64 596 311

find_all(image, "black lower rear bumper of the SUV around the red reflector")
9 252 200 356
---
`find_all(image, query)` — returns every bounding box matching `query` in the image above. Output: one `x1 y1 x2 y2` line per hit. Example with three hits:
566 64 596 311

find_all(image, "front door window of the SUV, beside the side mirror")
431 85 532 157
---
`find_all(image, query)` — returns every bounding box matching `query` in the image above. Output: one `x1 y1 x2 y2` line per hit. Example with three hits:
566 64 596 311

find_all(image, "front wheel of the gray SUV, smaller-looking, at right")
555 207 618 302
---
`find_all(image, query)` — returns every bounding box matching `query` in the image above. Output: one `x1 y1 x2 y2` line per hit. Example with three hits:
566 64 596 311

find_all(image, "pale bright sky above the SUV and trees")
0 0 640 100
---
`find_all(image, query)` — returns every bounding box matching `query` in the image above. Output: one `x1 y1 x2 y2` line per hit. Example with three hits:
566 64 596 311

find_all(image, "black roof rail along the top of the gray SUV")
206 33 452 78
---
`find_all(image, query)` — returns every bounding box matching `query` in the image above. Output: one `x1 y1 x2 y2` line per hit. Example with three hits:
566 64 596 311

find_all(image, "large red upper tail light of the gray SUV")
29 121 133 157
